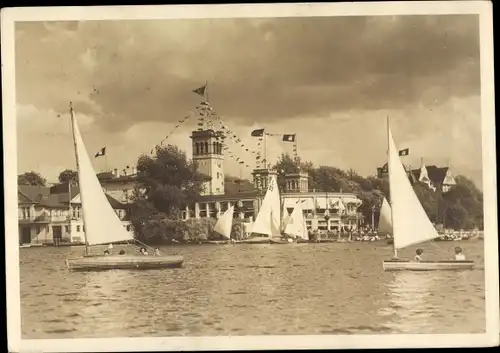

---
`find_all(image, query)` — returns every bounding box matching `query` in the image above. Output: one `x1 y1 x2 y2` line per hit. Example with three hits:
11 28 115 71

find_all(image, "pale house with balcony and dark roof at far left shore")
18 184 132 244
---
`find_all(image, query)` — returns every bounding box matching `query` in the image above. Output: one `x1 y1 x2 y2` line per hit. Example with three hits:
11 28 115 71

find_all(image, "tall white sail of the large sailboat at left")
71 106 133 245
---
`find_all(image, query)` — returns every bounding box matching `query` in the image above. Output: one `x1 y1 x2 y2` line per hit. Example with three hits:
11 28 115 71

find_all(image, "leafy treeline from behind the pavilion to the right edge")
274 154 483 230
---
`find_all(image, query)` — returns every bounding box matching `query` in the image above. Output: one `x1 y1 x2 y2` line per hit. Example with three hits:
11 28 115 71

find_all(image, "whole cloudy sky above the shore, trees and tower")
15 15 482 185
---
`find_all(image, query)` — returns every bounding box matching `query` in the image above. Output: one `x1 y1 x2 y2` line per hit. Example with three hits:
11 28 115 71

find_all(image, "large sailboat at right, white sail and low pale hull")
383 119 474 271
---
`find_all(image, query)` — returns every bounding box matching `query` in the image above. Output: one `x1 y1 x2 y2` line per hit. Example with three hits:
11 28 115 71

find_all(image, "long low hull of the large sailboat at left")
66 255 184 271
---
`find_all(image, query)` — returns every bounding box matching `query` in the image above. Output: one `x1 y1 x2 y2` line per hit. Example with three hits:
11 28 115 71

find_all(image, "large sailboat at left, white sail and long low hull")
66 103 183 271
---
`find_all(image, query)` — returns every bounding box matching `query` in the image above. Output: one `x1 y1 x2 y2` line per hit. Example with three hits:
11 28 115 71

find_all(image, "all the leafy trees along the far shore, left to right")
18 145 483 241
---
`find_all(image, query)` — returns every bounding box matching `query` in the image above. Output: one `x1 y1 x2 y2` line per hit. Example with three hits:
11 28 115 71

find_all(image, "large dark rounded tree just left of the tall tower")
131 145 207 241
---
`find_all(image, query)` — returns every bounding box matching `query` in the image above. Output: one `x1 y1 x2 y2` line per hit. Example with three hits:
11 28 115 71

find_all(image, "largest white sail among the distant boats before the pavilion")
252 176 281 237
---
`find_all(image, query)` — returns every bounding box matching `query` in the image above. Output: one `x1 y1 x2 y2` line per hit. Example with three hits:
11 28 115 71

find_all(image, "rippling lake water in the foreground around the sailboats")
20 241 485 338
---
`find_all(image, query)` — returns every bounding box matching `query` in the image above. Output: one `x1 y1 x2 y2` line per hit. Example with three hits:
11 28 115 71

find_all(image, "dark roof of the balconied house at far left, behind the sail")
18 183 128 209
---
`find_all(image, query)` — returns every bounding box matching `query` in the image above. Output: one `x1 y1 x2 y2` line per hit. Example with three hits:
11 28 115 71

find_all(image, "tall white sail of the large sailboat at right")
388 127 439 249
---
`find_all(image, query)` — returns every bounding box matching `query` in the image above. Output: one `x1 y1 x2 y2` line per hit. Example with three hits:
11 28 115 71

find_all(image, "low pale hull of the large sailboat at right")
383 260 474 271
